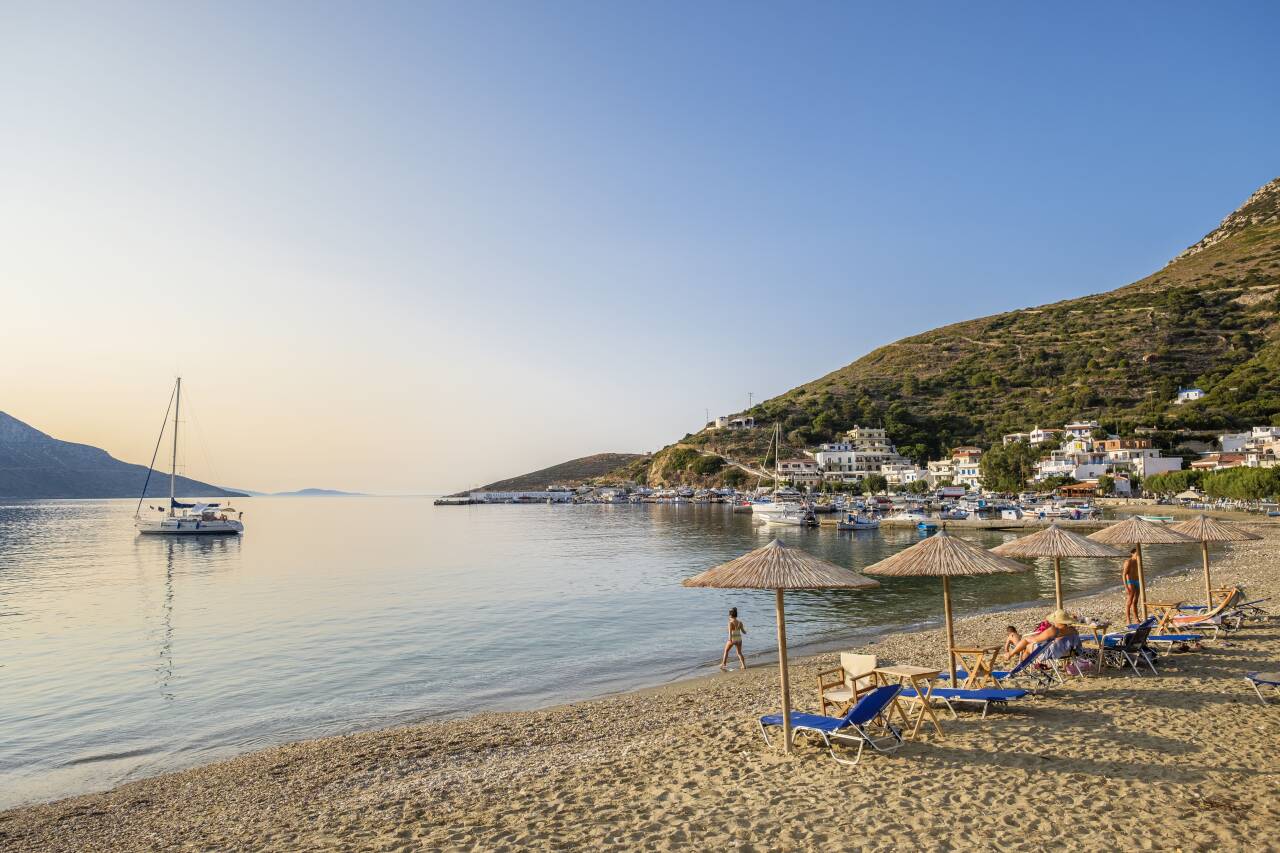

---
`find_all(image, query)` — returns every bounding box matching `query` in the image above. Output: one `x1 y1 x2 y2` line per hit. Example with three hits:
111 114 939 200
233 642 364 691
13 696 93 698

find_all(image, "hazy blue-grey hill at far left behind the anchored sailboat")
0 411 242 498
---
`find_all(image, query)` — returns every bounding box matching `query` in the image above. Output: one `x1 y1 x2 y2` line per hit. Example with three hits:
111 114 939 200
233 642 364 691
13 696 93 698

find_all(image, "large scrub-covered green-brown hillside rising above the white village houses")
650 178 1280 475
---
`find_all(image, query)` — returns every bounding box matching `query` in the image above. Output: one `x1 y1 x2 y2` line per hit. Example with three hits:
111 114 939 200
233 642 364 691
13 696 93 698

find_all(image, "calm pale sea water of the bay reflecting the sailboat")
0 498 1187 806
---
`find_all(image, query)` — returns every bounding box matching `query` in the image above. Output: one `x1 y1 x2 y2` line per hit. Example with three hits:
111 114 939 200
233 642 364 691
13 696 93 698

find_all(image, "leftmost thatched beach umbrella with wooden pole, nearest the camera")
684 539 879 752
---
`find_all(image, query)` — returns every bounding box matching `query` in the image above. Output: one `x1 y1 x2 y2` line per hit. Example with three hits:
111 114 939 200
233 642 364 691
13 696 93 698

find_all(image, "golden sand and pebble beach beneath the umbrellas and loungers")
0 514 1280 850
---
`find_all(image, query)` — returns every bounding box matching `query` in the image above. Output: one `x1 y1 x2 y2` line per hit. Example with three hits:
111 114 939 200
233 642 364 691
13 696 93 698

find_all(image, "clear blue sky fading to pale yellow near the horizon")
0 0 1280 493
